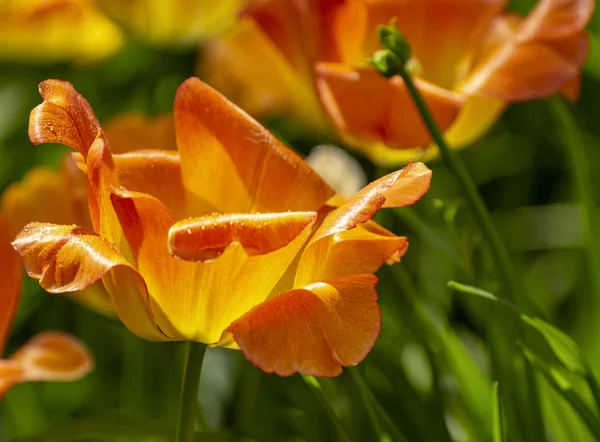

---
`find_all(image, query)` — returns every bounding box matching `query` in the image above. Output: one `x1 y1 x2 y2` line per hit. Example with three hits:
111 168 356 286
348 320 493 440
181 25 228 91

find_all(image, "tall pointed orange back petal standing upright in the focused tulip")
175 78 333 213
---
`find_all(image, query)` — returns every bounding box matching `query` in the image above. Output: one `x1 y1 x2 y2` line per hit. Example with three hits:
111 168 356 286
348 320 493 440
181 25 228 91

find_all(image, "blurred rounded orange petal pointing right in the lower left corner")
0 332 94 398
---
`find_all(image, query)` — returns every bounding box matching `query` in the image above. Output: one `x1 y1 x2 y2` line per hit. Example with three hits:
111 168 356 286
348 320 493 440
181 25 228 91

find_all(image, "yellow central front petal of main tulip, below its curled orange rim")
112 190 314 344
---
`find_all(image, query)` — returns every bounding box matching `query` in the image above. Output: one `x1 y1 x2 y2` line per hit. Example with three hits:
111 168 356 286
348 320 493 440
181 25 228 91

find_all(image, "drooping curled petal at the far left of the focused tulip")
13 223 166 340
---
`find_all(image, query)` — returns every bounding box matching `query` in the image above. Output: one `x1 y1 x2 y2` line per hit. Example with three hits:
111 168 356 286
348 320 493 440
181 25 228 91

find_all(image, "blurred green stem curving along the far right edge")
549 97 600 302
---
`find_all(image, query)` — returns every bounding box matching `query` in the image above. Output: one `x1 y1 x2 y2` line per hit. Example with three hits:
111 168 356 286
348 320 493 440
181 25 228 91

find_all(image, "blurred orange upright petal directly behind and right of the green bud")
365 0 506 89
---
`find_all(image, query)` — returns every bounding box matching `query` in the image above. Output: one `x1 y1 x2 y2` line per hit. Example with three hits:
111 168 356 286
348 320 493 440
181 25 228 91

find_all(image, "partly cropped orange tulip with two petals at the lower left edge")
0 215 94 398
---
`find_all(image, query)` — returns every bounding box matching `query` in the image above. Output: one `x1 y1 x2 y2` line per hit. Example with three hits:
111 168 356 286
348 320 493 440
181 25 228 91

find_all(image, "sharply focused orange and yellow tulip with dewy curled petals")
13 78 431 376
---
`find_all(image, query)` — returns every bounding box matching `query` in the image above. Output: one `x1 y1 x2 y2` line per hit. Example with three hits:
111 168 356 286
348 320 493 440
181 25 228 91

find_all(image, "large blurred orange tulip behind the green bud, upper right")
206 0 594 164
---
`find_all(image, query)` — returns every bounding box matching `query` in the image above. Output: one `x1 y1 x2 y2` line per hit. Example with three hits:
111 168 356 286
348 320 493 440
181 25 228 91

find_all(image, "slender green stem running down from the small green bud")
399 69 523 303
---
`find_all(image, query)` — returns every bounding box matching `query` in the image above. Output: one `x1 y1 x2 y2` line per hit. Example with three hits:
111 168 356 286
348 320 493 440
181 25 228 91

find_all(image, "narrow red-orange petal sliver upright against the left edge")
0 214 21 356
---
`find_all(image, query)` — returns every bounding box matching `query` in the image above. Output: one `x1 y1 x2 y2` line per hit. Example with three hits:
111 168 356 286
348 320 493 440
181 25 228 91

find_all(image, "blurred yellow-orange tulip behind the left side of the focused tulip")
0 114 176 316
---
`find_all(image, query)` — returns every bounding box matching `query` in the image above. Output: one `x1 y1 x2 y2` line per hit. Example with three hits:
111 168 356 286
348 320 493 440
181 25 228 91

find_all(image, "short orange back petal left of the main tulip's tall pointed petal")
111 151 187 218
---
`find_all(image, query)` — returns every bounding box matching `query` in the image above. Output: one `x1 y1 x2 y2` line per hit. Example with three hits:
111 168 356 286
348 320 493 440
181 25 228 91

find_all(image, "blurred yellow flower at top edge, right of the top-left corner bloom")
97 0 250 46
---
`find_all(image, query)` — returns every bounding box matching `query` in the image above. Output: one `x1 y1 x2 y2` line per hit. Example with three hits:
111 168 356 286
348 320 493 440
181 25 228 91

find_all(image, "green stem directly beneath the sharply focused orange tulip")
175 341 206 442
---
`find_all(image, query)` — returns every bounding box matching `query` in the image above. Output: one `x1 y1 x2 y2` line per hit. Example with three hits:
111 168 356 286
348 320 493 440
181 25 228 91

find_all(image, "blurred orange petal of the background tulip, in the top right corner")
457 0 594 101
